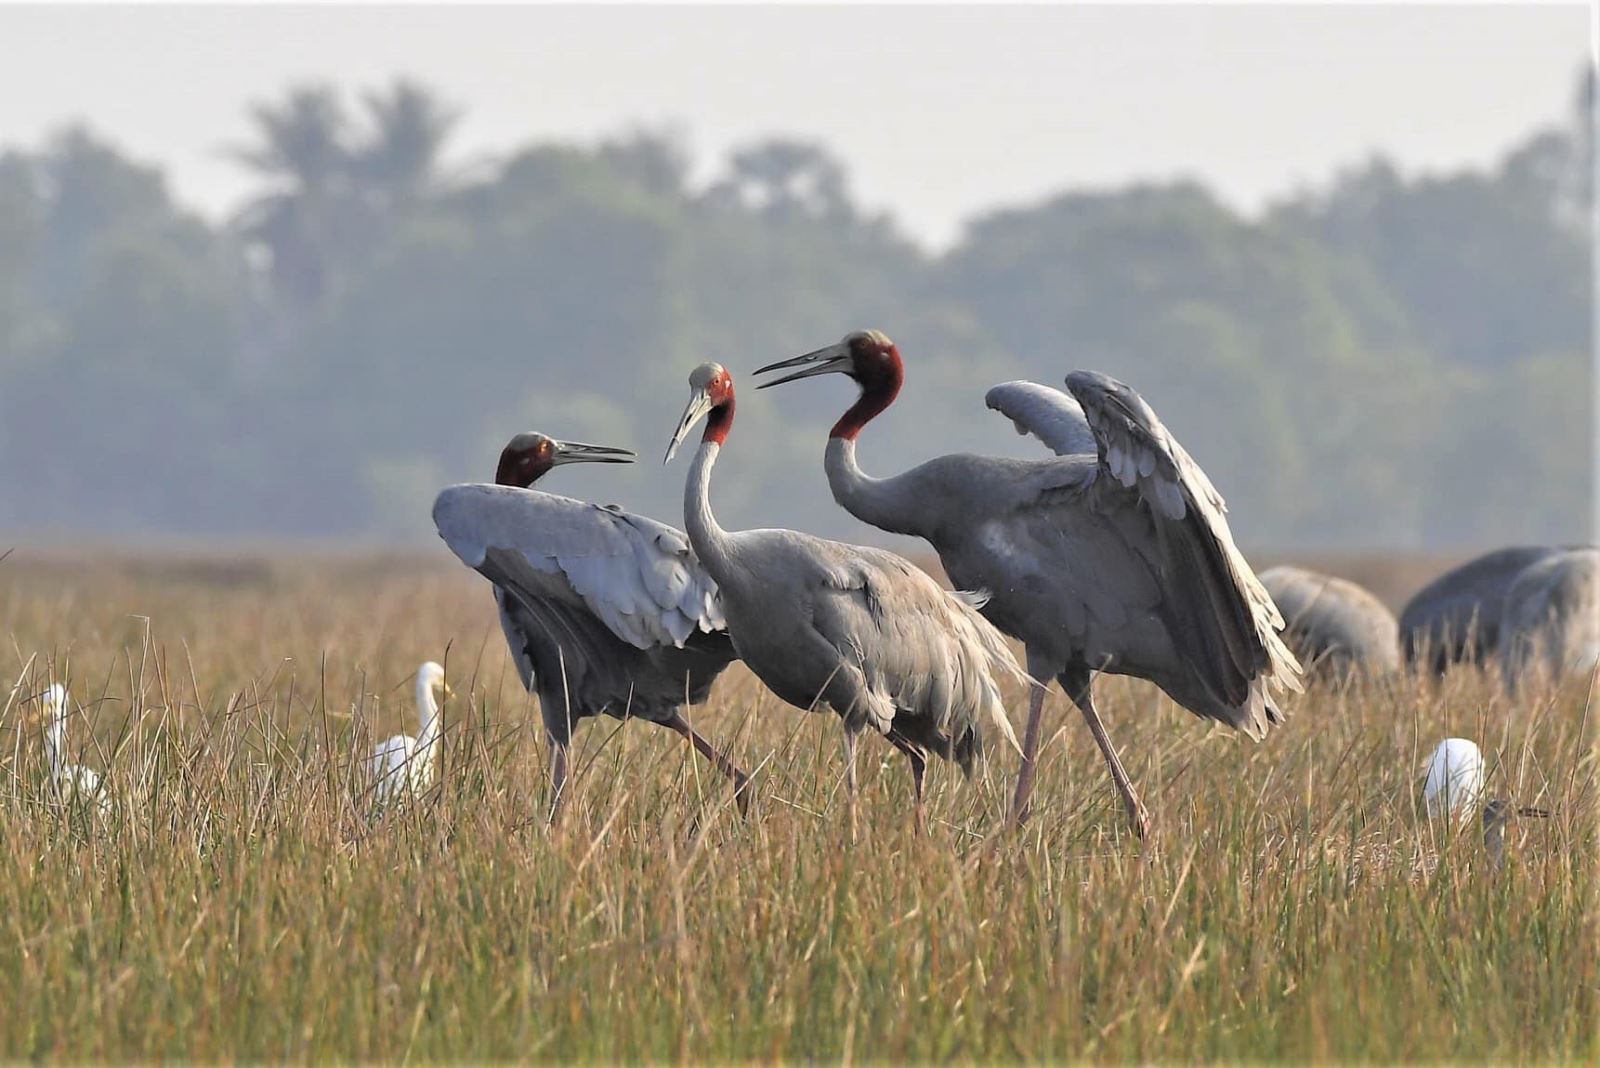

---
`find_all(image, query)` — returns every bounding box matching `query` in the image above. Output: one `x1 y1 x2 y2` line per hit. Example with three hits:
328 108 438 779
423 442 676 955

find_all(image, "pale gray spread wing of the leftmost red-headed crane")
434 483 726 649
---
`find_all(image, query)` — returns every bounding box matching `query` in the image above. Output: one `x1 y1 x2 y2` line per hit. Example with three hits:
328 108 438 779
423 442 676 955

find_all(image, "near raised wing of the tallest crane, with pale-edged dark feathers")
1067 371 1301 709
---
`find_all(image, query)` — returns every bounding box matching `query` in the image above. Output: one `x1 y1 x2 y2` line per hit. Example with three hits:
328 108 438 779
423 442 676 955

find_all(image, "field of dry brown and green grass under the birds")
0 555 1600 1062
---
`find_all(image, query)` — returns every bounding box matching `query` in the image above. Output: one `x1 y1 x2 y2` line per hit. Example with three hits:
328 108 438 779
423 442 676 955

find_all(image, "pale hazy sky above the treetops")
0 5 1589 243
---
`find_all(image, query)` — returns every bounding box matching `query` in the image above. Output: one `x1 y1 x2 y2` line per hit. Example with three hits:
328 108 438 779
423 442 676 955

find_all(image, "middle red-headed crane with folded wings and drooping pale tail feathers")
666 363 1026 833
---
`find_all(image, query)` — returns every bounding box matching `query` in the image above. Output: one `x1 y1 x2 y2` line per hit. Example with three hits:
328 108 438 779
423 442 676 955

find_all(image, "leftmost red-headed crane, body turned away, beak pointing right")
434 433 749 817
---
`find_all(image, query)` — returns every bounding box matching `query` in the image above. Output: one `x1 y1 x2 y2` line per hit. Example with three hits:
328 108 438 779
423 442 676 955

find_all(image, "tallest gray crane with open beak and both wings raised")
757 331 1301 838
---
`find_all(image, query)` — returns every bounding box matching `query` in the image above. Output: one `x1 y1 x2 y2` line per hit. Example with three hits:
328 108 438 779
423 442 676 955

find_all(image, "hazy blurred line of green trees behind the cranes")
0 78 1592 548
